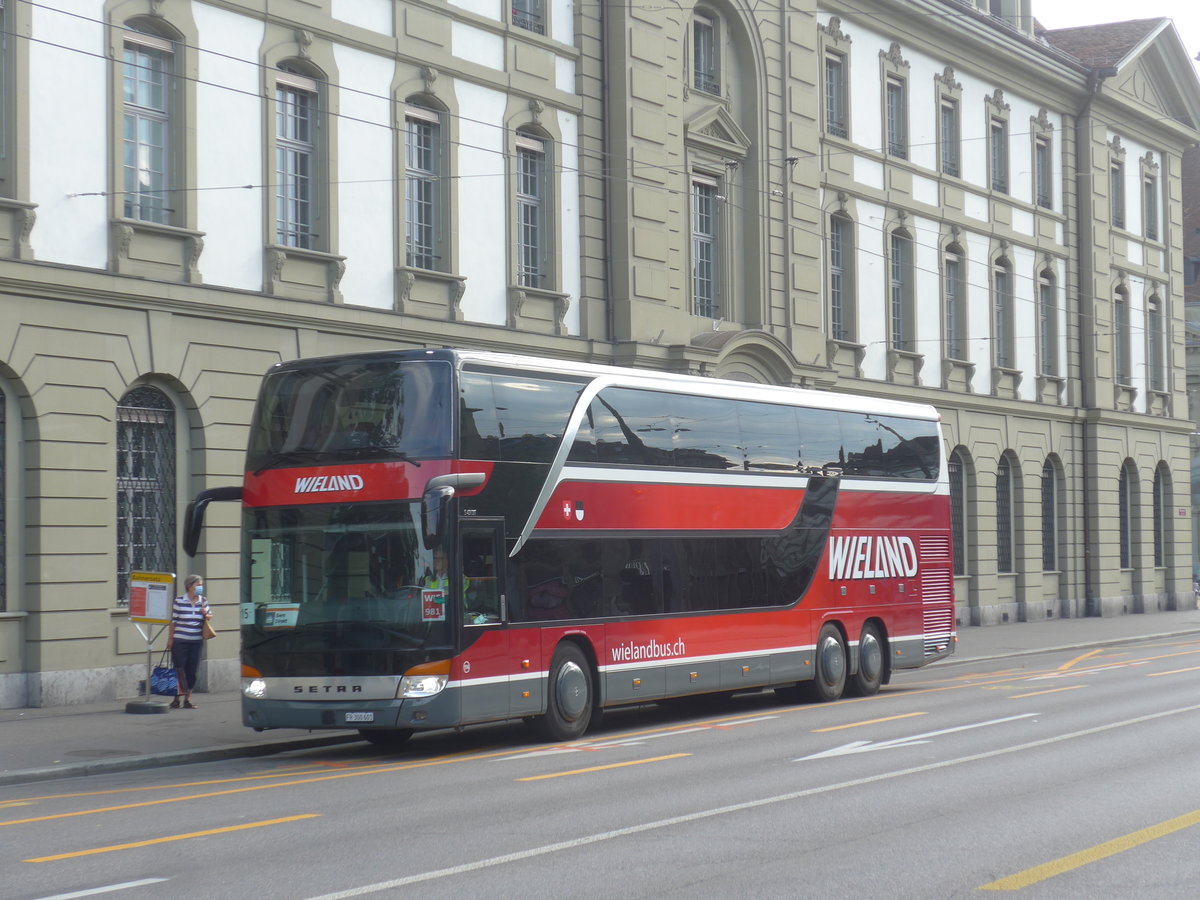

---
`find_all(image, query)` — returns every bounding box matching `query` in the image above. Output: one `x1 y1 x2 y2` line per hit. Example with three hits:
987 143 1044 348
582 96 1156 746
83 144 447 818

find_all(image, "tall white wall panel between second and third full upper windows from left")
334 47 398 310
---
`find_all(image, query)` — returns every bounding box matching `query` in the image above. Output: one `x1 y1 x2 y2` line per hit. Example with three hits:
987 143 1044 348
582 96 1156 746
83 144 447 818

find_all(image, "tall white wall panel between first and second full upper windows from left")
192 4 264 290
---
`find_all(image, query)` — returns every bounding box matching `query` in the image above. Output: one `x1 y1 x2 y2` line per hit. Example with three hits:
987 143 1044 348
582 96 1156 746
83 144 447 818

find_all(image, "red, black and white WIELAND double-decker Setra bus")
185 349 955 745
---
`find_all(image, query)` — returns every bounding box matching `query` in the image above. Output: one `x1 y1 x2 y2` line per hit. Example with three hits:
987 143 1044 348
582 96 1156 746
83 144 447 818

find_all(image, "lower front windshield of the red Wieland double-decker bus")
241 500 452 676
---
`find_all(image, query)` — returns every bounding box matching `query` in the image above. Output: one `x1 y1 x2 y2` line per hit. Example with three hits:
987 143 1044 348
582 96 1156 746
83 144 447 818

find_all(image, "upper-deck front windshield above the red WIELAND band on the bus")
246 359 452 472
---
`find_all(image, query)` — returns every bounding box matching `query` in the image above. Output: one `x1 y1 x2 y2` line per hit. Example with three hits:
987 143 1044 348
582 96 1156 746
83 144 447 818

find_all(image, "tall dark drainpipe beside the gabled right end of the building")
1075 66 1117 616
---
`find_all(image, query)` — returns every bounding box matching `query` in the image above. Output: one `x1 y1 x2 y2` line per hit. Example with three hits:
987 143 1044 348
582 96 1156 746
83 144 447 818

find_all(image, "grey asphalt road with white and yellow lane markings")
0 637 1200 900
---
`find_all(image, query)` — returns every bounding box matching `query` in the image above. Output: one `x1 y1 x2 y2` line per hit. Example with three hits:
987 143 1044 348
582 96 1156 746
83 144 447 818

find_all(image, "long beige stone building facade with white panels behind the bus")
0 0 1200 707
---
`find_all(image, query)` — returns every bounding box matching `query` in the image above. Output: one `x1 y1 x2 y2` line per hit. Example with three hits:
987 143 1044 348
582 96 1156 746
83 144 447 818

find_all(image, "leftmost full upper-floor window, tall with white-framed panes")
122 32 174 224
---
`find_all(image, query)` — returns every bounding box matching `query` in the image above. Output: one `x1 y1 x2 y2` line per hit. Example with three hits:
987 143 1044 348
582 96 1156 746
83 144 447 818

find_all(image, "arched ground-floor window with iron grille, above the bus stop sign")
116 385 175 606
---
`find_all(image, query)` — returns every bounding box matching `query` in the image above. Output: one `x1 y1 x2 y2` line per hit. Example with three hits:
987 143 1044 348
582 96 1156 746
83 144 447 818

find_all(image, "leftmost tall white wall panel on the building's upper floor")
26 0 113 269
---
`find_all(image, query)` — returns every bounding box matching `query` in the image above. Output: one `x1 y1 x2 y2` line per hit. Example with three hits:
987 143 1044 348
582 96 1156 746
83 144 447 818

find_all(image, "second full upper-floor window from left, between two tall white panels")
275 73 317 250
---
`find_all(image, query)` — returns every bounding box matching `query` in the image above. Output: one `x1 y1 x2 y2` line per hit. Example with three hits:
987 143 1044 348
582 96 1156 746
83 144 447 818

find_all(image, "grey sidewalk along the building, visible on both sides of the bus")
0 610 1200 786
